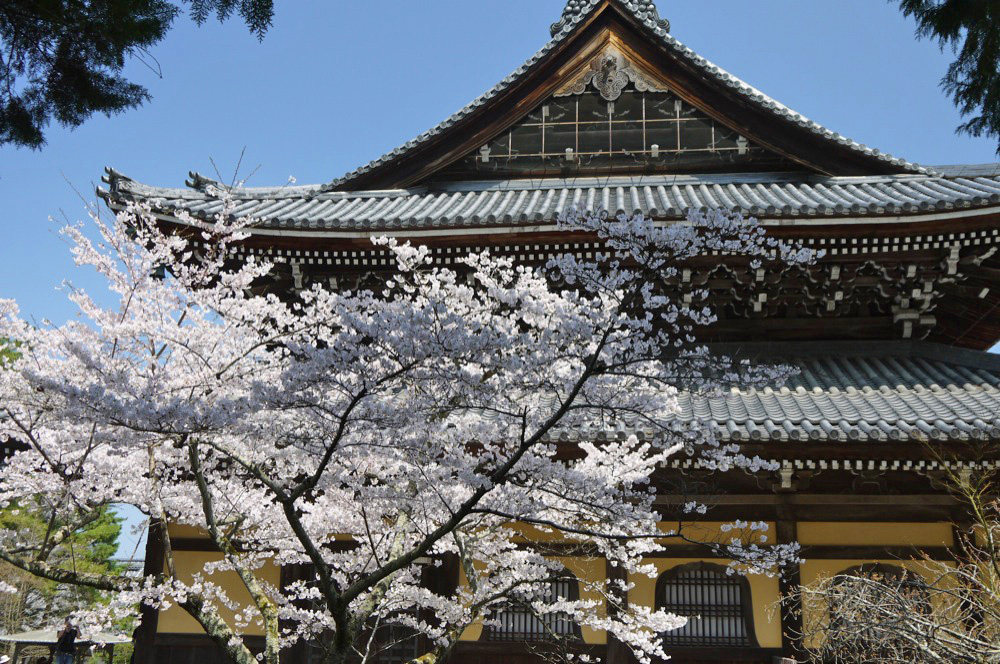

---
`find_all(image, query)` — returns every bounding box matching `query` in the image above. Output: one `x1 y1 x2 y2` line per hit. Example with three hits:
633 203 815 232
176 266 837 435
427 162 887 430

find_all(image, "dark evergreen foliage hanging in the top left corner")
0 0 274 149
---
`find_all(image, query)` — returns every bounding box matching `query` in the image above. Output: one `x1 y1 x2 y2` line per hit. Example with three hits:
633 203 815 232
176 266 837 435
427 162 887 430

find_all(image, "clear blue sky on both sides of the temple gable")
0 0 995 556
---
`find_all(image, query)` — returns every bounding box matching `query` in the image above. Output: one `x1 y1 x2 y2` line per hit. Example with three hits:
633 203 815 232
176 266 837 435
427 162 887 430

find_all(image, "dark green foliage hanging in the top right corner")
899 0 1000 154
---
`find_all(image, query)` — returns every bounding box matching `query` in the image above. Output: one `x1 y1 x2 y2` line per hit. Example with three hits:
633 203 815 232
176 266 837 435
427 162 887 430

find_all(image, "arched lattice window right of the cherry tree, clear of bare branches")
657 563 756 647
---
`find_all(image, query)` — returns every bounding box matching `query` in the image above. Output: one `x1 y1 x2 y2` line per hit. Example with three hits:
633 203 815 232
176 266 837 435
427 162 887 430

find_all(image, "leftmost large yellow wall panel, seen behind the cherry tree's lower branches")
156 551 281 636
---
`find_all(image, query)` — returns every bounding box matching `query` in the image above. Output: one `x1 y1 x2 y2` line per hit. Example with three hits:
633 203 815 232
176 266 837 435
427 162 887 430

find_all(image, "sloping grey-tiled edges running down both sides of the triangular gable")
327 0 931 188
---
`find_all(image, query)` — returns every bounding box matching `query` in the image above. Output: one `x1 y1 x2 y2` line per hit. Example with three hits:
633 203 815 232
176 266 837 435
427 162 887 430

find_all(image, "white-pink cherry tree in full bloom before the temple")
0 197 815 664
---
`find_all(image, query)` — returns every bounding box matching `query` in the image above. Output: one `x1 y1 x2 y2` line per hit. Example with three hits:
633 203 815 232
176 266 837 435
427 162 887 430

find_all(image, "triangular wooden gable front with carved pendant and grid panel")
434 40 801 180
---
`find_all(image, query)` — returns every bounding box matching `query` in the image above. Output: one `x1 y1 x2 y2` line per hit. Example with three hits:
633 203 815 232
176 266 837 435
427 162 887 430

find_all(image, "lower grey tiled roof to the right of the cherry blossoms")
548 342 1000 443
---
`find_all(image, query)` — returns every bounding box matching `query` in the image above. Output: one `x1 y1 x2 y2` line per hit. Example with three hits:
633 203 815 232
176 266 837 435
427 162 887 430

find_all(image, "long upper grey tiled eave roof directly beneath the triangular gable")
104 167 1000 231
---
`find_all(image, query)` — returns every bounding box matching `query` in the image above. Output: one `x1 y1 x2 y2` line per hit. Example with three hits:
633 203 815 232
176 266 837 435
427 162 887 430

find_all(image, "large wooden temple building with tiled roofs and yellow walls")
102 0 1000 664
